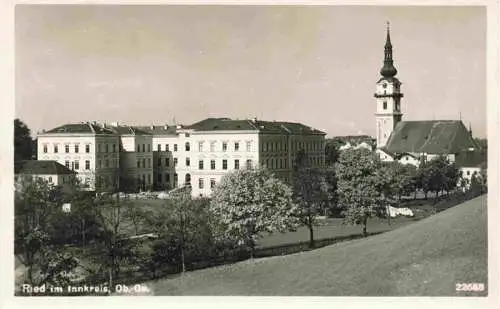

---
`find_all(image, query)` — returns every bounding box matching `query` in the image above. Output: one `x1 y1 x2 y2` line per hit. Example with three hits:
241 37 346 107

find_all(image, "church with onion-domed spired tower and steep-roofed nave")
374 24 486 184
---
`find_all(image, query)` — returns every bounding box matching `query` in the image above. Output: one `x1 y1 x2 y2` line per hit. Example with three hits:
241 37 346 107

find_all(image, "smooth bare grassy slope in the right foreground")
147 196 487 296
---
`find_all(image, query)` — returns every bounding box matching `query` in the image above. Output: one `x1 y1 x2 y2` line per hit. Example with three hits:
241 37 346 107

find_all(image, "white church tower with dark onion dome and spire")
375 22 403 148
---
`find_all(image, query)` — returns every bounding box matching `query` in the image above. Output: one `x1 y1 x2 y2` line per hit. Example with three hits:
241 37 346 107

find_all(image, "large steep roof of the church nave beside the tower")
384 120 477 154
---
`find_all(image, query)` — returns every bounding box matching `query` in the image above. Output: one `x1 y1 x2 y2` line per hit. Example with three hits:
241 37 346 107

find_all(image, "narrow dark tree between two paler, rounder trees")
293 151 329 248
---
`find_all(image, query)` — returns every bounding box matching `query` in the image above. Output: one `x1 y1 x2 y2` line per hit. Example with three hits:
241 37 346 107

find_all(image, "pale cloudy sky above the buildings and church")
15 5 486 137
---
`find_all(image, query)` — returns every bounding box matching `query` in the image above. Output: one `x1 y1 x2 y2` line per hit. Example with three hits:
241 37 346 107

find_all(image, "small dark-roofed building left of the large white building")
14 160 76 189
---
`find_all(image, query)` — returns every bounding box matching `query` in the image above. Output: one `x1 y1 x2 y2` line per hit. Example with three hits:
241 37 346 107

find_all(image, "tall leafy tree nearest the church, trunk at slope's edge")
336 149 388 237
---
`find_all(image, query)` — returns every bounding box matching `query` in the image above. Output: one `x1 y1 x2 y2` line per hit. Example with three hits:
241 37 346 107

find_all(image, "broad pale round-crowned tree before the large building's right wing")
210 169 298 257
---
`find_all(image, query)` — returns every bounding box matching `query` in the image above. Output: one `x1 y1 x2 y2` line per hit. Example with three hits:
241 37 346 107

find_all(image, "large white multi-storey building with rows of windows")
38 118 325 196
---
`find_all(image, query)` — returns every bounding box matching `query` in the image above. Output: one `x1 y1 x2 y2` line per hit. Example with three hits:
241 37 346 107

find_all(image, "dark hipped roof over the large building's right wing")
185 118 325 135
